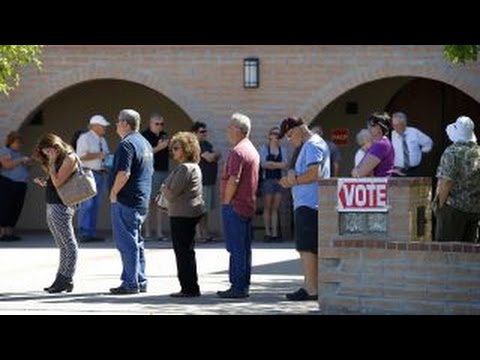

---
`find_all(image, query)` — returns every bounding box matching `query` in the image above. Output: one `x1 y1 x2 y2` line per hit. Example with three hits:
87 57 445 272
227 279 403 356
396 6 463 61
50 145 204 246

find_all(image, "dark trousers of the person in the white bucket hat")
435 204 480 242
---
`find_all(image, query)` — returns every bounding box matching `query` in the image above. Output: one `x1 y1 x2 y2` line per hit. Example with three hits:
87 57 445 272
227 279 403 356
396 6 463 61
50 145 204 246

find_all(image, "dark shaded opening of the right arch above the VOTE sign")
311 76 480 177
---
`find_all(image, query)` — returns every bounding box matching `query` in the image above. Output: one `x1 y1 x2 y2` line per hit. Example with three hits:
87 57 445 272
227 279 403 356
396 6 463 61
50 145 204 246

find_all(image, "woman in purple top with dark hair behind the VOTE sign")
352 112 395 178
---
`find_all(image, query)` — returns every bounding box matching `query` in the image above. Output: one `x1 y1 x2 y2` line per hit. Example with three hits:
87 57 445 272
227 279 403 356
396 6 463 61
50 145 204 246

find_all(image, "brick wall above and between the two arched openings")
0 45 480 147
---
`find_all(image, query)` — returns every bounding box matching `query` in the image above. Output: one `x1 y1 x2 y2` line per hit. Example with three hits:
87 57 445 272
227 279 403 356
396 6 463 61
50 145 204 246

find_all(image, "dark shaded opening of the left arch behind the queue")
17 79 192 230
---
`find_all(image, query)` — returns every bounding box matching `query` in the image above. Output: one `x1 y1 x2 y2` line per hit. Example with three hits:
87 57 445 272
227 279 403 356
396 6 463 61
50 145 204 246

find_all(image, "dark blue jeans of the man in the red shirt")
222 205 252 292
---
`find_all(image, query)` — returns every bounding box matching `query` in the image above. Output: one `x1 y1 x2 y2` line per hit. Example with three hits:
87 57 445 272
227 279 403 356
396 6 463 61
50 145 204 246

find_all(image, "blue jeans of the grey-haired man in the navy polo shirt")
111 202 147 289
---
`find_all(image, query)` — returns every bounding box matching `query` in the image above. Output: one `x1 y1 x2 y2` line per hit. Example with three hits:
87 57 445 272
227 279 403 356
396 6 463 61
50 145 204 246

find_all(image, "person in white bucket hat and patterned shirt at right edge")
433 116 480 242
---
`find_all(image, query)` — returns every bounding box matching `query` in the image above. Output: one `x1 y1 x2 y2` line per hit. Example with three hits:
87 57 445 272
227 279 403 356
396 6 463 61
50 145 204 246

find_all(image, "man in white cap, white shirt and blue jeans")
77 115 110 242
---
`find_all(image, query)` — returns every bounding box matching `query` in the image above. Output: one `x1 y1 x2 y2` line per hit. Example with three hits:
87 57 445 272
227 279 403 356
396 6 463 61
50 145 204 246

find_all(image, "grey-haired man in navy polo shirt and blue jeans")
110 109 153 295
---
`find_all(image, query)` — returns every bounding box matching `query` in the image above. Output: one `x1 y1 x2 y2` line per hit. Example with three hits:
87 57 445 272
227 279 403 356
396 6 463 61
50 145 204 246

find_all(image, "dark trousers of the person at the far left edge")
0 175 27 228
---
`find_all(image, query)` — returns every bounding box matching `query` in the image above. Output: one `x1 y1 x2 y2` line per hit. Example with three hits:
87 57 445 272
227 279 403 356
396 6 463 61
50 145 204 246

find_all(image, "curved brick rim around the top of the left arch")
5 62 217 141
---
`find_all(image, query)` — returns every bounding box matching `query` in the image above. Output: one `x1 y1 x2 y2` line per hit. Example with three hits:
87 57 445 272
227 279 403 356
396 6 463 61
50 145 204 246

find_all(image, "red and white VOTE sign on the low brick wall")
337 178 388 212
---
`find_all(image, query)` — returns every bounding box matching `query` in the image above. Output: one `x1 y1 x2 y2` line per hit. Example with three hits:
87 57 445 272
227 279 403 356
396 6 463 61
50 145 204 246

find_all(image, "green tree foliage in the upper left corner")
0 45 43 95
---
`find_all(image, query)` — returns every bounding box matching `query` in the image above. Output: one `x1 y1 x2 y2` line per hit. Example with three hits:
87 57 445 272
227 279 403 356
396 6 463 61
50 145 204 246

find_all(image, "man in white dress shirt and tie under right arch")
392 112 433 177
